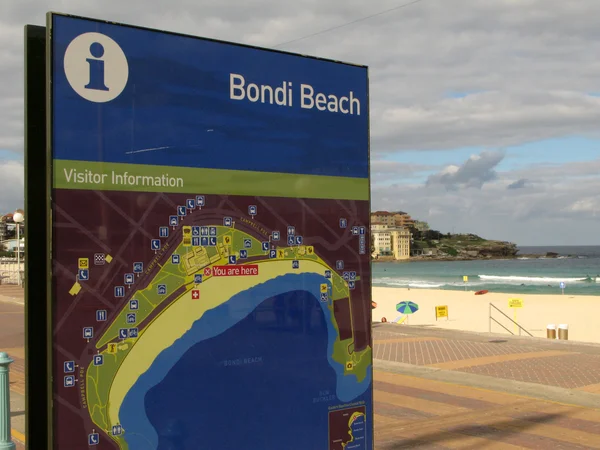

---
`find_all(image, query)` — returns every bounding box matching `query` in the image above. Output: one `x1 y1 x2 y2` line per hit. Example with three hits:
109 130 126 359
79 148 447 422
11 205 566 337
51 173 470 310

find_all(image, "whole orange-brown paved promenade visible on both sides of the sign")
0 286 600 450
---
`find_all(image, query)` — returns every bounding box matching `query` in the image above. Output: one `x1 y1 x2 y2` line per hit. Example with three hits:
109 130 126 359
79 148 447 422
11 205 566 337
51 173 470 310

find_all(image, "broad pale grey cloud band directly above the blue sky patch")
373 91 600 153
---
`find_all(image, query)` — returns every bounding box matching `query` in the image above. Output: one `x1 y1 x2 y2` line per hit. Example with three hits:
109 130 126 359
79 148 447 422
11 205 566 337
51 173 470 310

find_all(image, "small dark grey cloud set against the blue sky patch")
426 151 504 189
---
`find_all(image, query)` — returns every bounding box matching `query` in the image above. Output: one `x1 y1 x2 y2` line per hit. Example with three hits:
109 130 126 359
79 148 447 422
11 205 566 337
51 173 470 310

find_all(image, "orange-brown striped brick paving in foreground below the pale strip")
374 371 600 450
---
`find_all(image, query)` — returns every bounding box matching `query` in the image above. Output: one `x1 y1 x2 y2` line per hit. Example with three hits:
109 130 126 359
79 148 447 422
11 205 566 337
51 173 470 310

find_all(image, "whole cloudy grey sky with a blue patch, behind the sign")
0 0 600 245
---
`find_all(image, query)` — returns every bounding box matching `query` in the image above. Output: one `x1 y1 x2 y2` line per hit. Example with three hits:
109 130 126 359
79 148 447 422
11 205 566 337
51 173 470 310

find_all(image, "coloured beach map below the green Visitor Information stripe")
52 191 372 449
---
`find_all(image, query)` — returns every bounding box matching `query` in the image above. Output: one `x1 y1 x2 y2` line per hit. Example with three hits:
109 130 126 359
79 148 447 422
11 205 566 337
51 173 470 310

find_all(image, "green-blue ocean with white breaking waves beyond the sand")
373 246 600 295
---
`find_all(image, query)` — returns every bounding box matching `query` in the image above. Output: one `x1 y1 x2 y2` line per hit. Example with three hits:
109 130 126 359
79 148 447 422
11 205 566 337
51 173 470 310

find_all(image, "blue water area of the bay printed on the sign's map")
119 273 372 450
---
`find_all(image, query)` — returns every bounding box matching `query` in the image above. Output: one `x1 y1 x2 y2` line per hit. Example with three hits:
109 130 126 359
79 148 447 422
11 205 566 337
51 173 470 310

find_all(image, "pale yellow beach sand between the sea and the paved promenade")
373 287 600 343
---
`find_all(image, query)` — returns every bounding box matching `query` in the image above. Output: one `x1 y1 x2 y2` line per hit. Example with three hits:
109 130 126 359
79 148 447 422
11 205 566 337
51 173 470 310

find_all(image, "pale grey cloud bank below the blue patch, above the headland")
372 172 600 245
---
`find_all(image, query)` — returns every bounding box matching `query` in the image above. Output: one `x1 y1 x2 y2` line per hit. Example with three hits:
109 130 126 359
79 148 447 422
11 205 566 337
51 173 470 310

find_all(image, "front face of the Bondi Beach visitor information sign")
48 15 373 450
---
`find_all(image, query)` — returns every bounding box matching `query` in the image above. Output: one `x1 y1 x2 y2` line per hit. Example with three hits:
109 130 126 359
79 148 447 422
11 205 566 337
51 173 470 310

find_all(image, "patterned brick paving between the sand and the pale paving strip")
373 325 600 392
